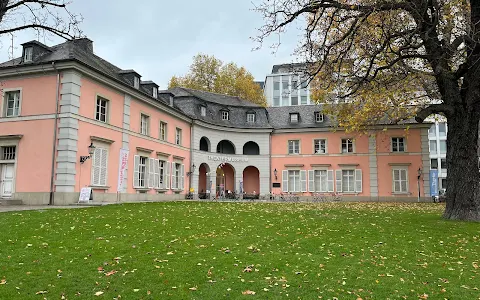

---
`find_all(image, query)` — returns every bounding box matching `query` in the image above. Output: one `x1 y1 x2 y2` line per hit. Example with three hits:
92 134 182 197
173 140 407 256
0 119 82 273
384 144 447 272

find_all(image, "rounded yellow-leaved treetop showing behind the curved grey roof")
168 54 266 106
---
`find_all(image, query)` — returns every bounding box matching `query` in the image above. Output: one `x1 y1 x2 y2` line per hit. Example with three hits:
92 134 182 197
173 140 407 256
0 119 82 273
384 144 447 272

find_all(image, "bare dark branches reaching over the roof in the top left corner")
0 0 83 39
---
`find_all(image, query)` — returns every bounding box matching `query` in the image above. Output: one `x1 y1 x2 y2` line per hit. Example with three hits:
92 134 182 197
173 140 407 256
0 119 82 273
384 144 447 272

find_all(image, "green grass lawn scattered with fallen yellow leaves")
0 202 480 299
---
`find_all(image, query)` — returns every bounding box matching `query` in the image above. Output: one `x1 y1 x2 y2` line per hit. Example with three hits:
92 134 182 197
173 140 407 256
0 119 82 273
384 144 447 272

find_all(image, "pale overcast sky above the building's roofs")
0 0 304 89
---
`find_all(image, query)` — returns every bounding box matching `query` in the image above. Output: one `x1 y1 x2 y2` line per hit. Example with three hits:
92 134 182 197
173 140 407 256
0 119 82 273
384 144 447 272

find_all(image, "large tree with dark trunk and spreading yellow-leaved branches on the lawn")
256 0 480 221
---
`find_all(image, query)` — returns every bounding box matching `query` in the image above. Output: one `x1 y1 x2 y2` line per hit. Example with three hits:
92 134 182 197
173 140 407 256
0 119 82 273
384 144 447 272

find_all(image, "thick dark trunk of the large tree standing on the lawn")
443 105 480 221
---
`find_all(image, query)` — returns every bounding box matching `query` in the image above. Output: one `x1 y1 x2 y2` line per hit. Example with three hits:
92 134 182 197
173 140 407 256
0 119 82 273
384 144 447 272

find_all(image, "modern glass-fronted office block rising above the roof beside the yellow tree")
263 64 311 106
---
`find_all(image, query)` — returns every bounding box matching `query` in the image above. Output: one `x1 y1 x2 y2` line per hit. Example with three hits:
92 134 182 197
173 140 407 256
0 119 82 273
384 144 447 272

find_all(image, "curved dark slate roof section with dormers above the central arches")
168 87 271 128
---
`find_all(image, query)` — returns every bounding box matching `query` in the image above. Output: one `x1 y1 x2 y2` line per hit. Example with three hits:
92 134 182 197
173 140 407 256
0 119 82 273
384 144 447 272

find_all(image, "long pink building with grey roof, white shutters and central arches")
0 39 429 204
